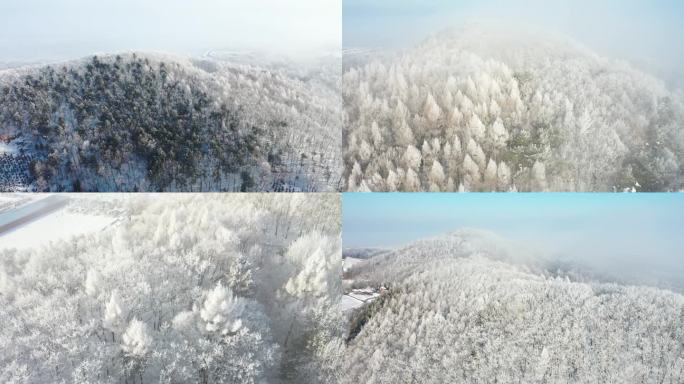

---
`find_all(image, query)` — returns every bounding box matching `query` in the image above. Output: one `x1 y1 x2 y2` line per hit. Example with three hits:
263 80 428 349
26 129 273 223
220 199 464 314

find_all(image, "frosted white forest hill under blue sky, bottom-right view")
340 230 684 384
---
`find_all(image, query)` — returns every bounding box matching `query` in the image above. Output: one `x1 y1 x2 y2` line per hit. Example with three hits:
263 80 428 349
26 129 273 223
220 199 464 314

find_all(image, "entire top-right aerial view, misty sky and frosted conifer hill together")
342 1 684 192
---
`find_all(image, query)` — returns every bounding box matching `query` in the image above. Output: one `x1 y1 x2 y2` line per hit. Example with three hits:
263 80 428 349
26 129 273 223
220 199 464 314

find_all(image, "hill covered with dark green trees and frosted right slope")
0 54 341 191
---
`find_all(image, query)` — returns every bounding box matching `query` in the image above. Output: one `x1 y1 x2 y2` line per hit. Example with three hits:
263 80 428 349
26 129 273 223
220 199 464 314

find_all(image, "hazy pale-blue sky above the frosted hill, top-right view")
343 0 684 88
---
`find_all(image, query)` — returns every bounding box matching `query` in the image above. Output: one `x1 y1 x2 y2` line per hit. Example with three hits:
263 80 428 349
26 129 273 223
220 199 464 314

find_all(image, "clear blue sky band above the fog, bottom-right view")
343 193 684 248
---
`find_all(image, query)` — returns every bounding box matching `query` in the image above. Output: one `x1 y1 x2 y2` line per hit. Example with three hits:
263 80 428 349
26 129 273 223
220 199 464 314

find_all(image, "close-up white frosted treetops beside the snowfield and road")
0 194 345 384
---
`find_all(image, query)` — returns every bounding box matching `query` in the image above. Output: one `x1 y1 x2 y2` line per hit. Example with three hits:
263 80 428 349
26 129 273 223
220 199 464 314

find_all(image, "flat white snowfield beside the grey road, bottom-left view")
0 195 116 250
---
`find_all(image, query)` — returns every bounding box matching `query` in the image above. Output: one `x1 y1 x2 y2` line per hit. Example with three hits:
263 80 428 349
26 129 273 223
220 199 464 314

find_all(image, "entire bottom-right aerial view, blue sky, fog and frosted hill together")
339 193 684 384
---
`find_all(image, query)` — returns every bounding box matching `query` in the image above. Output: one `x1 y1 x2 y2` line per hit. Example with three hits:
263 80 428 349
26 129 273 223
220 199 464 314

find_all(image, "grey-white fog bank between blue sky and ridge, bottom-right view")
358 225 684 293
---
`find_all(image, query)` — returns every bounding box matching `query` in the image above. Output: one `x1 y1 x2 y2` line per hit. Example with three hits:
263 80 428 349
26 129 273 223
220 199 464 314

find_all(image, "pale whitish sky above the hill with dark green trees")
0 0 342 61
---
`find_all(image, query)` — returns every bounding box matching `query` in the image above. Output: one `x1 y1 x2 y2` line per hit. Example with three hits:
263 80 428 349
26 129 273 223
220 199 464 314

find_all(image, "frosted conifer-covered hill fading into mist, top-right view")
342 24 684 191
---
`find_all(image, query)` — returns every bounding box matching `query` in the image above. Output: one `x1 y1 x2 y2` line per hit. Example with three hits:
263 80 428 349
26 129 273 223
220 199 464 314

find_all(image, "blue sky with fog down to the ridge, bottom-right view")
342 193 684 285
